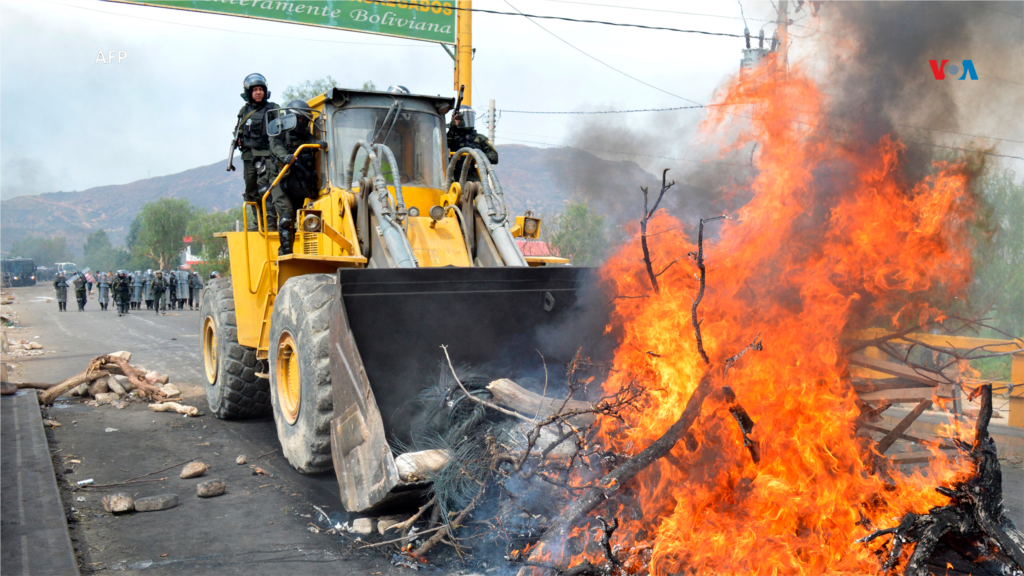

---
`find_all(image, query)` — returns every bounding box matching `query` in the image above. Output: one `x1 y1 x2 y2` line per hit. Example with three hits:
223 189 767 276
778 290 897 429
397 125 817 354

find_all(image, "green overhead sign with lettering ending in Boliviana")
106 0 457 44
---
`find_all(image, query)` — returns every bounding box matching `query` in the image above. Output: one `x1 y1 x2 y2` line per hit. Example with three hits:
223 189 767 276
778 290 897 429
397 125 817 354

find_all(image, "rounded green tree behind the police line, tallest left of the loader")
128 198 199 269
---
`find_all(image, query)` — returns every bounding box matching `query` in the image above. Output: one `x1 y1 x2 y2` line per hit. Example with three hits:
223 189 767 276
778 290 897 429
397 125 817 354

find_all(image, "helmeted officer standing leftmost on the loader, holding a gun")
228 74 278 231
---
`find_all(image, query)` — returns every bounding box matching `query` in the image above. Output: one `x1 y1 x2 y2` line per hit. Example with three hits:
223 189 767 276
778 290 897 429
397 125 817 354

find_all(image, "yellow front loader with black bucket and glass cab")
202 88 585 511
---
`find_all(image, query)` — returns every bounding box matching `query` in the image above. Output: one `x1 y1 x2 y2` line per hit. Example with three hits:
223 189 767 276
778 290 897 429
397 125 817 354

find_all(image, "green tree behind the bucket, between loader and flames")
543 201 608 266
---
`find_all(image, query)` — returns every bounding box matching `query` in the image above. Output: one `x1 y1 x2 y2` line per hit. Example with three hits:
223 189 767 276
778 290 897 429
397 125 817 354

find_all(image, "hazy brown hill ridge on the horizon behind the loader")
0 145 656 253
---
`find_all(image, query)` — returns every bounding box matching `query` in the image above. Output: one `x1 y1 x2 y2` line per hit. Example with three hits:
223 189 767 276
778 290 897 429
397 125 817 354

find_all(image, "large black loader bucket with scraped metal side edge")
331 266 590 511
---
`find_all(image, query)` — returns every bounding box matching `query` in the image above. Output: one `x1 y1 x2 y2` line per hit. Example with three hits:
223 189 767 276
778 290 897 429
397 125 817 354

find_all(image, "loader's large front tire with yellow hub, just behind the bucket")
269 274 338 474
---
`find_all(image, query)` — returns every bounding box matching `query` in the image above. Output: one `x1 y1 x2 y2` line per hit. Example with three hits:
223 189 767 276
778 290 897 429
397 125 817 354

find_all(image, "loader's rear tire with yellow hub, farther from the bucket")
200 278 270 419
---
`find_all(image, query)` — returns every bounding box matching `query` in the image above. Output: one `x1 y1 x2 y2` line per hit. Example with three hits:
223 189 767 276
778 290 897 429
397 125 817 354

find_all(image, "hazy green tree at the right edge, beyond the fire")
971 170 1024 337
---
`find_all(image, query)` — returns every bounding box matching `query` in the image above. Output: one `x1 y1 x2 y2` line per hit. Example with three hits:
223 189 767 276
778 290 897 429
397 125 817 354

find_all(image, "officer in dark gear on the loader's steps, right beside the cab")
270 100 327 256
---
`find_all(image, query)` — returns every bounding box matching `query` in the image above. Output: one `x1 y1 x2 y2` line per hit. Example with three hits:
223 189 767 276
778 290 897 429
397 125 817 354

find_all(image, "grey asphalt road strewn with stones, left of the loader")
4 285 419 576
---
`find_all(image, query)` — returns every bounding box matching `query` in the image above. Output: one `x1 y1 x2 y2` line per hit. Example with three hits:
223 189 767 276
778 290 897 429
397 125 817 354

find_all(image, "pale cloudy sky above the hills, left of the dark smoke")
0 0 782 199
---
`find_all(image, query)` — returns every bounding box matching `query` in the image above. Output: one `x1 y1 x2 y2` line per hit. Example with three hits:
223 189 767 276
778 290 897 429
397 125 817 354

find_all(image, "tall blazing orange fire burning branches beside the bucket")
581 56 976 576
